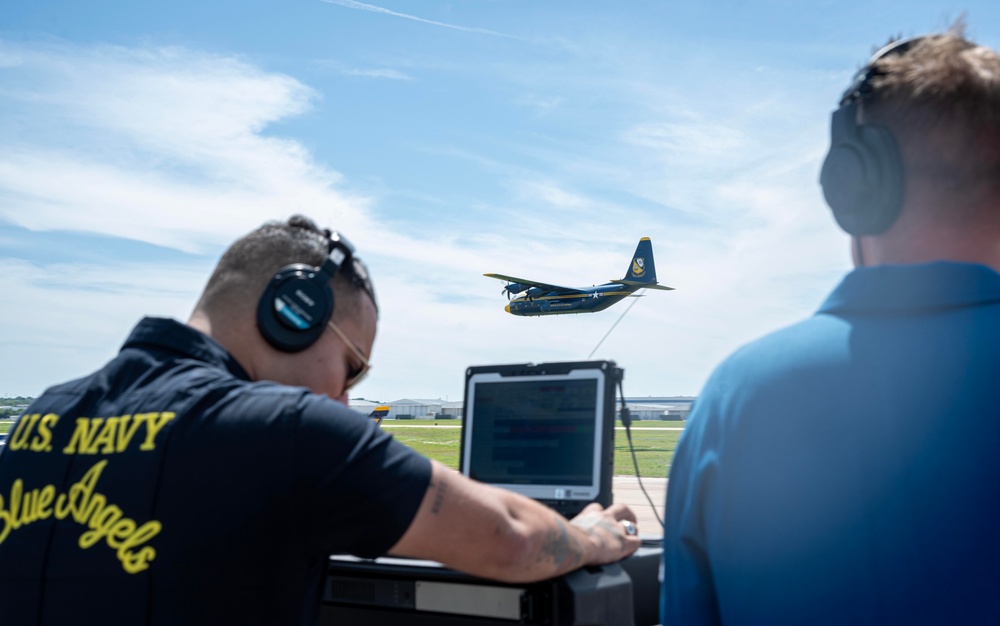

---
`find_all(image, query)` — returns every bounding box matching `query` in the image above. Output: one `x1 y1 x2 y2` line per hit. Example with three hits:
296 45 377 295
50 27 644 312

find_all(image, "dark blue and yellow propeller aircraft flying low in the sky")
483 237 673 315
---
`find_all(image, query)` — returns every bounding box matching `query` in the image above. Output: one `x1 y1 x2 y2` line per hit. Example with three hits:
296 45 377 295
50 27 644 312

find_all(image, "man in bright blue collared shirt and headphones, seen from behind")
662 28 1000 625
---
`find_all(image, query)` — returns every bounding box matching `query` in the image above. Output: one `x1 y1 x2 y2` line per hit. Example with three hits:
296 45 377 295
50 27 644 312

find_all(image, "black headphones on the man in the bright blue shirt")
819 37 923 235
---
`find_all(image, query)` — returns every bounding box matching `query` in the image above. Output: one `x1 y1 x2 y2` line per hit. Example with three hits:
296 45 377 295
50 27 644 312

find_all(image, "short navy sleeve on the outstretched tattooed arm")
293 394 431 558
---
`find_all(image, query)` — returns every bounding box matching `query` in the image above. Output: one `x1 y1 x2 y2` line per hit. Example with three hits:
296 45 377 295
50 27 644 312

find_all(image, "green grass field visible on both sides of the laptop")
382 420 684 478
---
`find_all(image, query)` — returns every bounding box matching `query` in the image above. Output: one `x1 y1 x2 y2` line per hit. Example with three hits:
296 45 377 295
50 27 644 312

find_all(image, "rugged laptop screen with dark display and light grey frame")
460 361 620 515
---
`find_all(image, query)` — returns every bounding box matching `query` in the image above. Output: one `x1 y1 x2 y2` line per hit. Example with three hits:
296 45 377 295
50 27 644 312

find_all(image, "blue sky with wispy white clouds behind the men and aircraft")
0 0 1000 401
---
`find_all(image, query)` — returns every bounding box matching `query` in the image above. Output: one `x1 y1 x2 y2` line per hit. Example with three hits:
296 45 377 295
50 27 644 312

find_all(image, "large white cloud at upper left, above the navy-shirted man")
0 44 365 251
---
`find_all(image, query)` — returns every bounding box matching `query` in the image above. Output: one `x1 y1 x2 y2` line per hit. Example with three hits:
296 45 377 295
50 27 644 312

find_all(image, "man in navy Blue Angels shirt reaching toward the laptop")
0 216 639 626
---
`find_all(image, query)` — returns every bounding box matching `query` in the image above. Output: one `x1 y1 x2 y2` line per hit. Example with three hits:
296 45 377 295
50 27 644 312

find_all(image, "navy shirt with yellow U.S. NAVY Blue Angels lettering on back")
0 318 430 626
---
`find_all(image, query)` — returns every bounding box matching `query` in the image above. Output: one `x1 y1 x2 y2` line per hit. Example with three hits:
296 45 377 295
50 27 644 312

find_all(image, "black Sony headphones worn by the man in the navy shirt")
257 231 354 352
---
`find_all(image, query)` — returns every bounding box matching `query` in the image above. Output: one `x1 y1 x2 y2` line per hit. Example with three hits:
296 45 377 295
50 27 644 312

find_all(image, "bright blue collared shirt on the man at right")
662 262 1000 624
